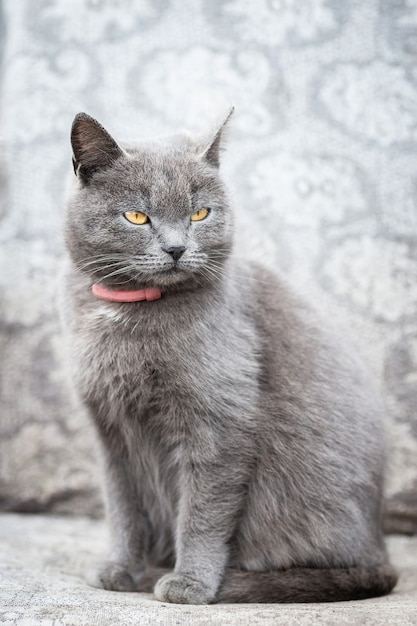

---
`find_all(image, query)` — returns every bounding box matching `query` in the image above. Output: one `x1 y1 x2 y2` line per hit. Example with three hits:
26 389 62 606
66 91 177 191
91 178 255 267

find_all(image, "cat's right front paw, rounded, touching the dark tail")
154 574 215 604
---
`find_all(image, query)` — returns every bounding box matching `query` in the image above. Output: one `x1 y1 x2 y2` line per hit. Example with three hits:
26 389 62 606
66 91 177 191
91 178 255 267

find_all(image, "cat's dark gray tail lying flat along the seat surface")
216 563 398 602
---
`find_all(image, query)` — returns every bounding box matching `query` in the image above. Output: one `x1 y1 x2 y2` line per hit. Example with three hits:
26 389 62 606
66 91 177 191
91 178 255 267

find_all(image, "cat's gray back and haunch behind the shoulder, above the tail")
234 260 383 569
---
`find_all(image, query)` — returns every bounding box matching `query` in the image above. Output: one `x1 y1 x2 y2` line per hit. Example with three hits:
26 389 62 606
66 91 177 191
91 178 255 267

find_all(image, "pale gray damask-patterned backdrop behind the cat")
0 0 417 531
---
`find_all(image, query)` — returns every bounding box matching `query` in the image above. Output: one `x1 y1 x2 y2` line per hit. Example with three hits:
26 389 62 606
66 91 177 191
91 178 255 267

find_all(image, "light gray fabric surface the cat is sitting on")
0 514 417 626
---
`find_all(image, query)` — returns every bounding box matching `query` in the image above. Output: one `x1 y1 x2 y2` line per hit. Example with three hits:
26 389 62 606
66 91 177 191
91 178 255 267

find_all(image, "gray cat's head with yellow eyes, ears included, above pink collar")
66 111 233 288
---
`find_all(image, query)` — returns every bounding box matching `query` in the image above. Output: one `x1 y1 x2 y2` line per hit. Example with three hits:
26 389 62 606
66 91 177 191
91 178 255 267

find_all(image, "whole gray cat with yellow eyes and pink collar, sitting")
66 113 396 604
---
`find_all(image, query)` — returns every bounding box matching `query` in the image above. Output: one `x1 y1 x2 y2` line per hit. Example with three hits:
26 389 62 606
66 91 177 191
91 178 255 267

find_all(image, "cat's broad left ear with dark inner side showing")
71 113 124 183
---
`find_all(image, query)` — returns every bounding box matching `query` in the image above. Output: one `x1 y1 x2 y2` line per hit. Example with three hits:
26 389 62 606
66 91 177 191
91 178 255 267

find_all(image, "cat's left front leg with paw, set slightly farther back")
86 422 148 591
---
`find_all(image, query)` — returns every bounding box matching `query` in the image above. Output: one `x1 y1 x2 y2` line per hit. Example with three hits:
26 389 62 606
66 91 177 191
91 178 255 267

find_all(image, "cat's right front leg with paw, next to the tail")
154 446 247 604
